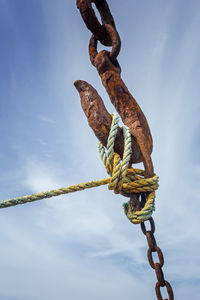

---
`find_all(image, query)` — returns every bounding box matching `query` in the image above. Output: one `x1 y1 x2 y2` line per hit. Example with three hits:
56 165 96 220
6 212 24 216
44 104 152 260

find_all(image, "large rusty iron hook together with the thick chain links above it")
75 0 154 179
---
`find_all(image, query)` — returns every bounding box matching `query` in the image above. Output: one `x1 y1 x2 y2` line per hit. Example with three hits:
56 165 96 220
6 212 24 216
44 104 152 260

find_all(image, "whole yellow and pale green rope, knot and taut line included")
0 114 158 224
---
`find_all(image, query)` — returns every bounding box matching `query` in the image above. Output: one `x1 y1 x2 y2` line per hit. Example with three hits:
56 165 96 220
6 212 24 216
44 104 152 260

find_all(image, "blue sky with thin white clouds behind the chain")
0 0 200 300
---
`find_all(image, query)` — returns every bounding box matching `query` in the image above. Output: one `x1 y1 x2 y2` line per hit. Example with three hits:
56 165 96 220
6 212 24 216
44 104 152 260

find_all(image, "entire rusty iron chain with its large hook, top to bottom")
75 0 174 300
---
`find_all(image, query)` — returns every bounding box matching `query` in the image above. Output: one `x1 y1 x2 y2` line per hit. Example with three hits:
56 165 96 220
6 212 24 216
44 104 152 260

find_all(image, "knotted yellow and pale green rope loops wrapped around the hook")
98 114 158 224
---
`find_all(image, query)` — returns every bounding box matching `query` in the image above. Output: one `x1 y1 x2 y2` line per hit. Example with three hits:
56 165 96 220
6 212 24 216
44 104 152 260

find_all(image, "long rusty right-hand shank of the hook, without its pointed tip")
89 38 154 177
